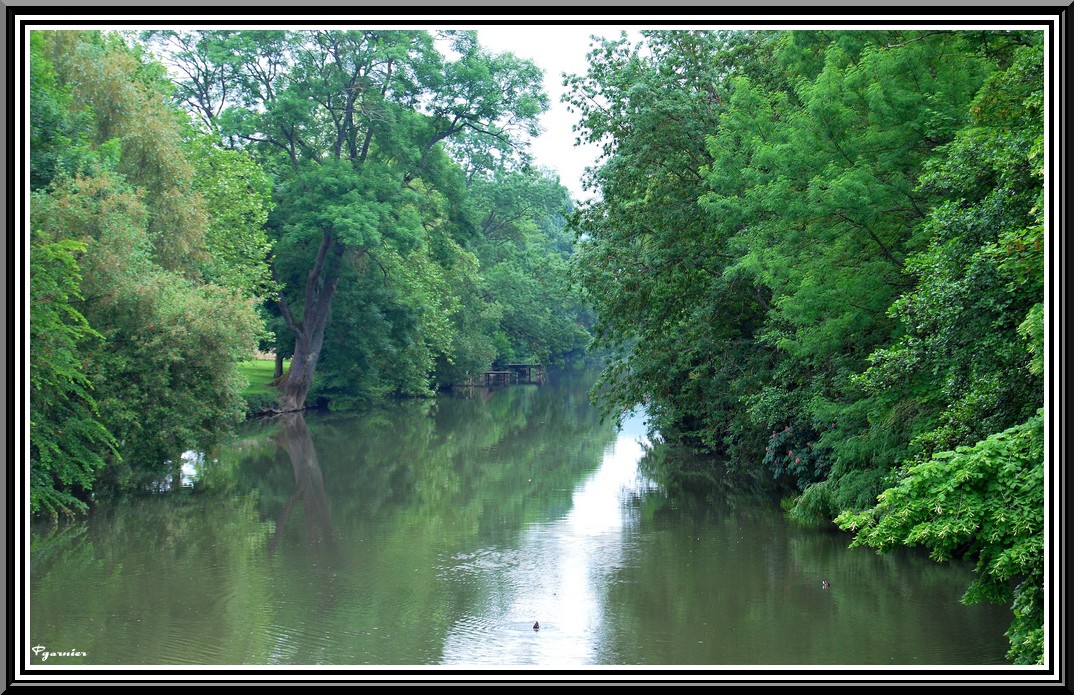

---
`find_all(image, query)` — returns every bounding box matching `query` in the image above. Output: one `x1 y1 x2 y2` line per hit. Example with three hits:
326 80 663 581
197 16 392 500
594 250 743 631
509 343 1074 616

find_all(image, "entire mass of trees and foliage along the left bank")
31 25 587 511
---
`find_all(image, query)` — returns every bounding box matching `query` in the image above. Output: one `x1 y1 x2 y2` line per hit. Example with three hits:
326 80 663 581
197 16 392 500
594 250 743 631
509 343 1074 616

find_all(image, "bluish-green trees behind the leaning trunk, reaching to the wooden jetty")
309 154 587 408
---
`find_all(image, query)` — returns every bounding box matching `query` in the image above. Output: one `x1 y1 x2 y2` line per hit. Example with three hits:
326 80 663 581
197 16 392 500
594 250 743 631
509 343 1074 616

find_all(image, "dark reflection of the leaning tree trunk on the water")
269 412 336 551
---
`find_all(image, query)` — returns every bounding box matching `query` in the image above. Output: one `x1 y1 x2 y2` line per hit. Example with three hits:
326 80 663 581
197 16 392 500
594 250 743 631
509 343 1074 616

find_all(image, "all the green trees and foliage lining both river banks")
28 29 1046 664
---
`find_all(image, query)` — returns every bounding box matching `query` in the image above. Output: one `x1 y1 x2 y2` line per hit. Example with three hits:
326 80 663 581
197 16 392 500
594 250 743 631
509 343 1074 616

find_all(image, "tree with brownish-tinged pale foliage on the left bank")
30 31 268 498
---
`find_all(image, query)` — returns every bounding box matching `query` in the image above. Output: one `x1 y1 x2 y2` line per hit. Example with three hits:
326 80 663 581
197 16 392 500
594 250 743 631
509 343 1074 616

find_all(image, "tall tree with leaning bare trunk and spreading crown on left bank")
156 30 546 410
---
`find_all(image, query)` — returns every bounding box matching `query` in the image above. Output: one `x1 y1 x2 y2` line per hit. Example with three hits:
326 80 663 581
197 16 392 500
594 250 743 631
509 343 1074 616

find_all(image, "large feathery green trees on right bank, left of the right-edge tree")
570 31 1031 504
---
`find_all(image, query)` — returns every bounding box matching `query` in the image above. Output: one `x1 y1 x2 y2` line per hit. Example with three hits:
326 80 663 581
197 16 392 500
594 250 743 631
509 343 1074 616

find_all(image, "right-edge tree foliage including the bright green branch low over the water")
837 38 1044 664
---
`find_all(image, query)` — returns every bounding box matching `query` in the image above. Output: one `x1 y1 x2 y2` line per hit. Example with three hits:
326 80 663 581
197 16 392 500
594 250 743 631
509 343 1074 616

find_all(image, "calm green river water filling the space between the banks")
28 375 1010 670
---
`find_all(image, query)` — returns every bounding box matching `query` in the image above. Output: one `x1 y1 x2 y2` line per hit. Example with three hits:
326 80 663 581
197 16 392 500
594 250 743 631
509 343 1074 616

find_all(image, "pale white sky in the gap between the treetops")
475 25 625 206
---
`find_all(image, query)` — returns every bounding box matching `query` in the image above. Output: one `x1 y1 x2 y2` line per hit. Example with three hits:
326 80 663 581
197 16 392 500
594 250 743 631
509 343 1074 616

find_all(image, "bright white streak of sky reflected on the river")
442 416 655 667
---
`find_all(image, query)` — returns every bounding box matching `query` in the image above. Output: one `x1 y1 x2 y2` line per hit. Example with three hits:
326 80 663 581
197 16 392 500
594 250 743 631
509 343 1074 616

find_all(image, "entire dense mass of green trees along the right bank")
569 30 1044 663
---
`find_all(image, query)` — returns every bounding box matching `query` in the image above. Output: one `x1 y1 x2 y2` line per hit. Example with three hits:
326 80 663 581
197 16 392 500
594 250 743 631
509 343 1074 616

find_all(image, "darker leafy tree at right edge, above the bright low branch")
861 39 1044 457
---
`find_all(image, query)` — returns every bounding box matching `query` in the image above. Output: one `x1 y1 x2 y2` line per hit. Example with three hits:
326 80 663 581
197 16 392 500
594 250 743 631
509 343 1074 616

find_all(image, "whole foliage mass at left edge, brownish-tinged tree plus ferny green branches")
30 31 267 513
